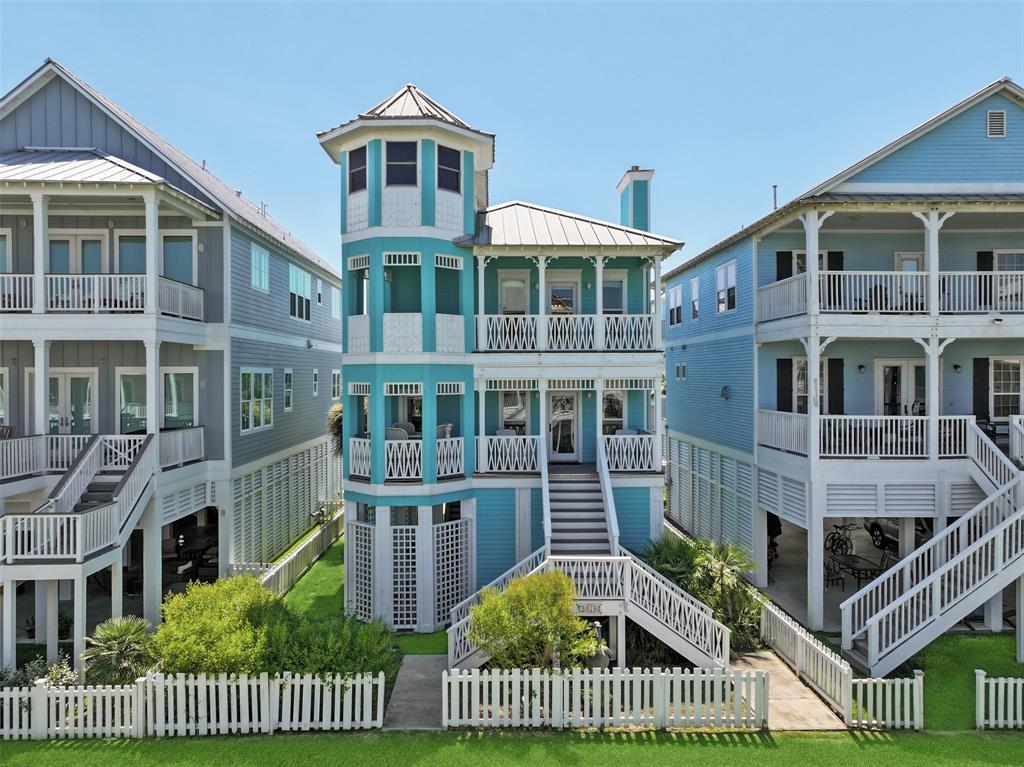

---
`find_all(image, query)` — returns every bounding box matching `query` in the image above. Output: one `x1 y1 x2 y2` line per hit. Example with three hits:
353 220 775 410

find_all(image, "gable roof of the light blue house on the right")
662 77 1024 282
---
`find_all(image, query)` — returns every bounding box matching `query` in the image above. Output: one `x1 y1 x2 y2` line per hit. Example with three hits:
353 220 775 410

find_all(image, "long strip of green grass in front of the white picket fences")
6 731 1024 767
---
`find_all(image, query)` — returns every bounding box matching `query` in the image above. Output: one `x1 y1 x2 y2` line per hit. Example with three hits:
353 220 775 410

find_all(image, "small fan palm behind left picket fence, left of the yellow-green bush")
82 615 154 684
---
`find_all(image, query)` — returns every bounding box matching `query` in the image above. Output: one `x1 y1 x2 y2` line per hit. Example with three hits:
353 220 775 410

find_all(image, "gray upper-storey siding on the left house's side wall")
231 226 341 342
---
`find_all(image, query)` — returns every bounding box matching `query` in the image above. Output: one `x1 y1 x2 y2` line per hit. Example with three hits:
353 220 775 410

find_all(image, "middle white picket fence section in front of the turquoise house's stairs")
441 669 768 729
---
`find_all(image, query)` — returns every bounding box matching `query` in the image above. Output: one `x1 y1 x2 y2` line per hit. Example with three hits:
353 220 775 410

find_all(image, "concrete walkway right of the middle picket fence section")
737 650 846 730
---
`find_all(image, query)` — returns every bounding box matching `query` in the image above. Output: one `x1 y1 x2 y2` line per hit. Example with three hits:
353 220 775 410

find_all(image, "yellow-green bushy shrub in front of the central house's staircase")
469 571 600 669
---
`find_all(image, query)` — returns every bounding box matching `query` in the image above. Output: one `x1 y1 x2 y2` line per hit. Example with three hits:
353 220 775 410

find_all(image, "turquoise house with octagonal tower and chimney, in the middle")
319 85 681 662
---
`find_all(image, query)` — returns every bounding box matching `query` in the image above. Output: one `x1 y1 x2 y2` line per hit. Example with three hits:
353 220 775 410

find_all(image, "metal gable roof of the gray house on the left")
0 58 340 279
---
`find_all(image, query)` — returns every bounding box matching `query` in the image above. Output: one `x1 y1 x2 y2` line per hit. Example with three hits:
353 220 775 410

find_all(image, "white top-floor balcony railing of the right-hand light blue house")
758 271 1024 323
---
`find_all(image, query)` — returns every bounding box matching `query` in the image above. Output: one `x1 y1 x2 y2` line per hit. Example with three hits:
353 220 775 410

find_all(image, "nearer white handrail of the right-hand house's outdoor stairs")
866 478 1024 667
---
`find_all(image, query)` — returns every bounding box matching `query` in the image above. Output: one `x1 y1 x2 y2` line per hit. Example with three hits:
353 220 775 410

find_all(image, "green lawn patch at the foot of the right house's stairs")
901 632 1024 733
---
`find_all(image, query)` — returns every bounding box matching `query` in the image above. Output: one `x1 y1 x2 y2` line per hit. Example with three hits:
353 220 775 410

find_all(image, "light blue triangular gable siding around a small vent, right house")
848 93 1024 183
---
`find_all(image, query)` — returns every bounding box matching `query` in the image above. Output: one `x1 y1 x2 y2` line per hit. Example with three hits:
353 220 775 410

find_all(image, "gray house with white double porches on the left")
0 59 341 665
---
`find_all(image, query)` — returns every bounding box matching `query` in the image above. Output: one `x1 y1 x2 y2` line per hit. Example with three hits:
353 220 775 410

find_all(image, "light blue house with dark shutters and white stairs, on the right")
664 79 1024 673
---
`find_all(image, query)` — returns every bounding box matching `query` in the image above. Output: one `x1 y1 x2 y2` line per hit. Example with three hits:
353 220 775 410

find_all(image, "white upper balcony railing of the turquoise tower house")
478 314 654 351
